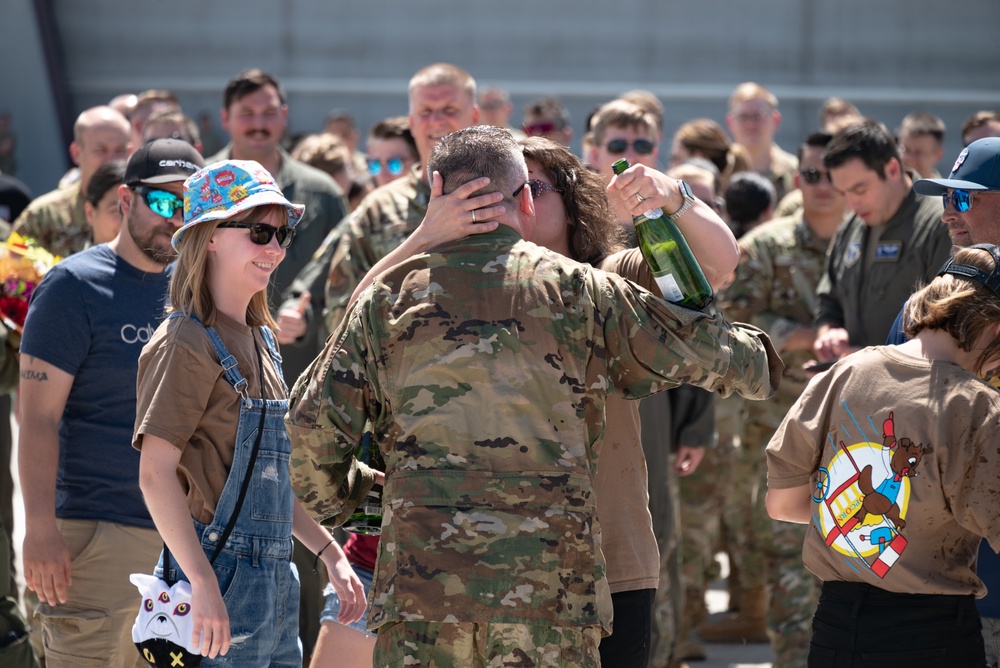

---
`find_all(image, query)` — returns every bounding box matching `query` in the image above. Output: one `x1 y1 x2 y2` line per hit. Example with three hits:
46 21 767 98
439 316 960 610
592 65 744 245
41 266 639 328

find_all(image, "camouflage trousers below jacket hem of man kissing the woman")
373 622 601 668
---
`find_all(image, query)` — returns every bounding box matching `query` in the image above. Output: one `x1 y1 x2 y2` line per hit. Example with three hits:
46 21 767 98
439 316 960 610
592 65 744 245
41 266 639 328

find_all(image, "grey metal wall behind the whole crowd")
0 0 1000 196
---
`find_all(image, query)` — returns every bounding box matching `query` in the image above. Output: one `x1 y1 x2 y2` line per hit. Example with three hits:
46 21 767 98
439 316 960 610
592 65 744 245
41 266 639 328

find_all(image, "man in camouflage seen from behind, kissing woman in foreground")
287 126 780 667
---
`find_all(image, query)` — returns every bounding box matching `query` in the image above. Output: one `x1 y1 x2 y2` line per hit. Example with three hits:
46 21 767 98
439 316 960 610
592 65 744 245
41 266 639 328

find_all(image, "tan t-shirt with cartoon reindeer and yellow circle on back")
767 346 1000 596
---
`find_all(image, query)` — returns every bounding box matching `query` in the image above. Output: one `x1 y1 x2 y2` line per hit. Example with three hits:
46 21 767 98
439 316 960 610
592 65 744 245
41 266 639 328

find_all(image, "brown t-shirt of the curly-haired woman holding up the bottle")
594 249 660 594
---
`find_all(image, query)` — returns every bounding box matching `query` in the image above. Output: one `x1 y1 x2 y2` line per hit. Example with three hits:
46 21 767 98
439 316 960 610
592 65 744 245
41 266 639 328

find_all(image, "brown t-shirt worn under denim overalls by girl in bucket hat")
132 313 287 523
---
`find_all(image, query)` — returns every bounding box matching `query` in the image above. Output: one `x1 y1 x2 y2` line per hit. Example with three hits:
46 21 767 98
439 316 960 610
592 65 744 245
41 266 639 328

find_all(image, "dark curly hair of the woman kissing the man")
521 137 626 265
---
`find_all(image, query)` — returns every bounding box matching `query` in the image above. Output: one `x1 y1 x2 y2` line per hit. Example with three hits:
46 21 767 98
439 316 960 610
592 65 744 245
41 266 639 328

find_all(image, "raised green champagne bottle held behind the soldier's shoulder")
612 158 714 311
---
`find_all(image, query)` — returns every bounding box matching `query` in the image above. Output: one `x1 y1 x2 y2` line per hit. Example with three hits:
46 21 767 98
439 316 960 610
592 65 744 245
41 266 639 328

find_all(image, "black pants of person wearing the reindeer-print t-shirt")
809 582 986 668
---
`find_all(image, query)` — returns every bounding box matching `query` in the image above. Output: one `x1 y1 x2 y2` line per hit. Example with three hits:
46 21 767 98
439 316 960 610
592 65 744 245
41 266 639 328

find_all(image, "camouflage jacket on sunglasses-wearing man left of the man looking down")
719 211 829 418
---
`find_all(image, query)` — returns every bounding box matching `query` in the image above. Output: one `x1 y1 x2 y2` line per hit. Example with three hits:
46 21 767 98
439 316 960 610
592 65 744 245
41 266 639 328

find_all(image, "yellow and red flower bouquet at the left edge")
0 233 62 334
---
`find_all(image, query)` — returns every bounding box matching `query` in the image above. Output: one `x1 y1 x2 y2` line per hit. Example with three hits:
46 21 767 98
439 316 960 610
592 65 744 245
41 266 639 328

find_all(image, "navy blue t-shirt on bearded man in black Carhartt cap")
21 244 172 529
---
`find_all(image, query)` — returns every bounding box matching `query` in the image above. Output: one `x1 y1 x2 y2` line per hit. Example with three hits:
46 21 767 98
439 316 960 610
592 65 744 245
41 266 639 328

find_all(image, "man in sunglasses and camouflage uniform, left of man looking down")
699 132 844 668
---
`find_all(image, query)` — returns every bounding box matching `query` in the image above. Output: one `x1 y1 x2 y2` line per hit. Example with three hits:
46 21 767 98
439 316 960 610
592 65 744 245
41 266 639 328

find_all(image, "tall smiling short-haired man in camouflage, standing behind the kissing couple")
284 63 479 340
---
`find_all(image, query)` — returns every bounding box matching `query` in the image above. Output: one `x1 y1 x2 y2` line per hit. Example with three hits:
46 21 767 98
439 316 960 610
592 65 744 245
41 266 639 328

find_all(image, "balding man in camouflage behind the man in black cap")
14 106 131 257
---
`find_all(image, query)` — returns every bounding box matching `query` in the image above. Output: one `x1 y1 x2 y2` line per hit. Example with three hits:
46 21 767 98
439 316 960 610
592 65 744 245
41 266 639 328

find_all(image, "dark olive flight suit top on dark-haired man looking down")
816 185 951 346
